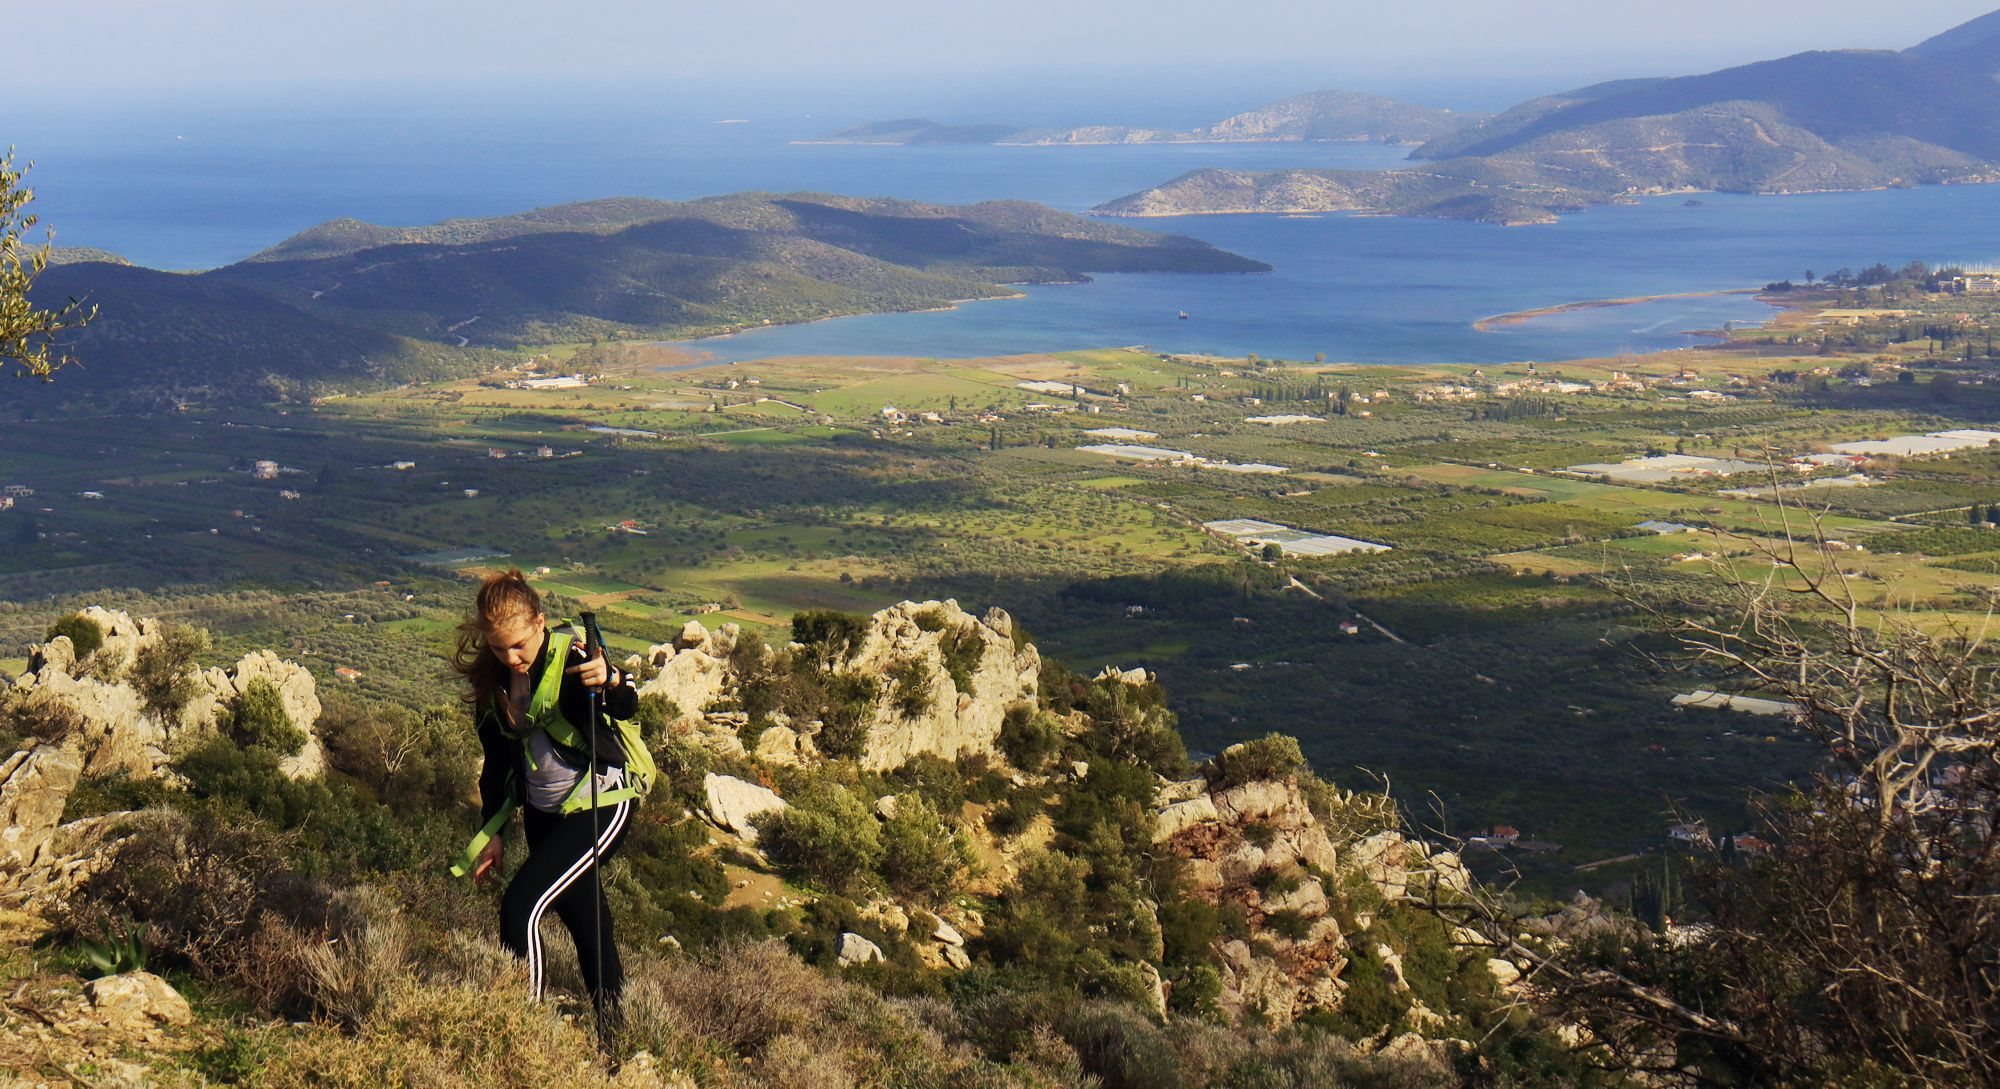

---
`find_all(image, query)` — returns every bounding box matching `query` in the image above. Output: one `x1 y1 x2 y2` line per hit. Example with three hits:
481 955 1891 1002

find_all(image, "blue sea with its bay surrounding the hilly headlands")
10 90 2000 364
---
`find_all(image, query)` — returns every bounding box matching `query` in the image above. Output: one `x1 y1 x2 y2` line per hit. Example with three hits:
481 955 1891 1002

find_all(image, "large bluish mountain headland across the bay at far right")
1096 12 2000 224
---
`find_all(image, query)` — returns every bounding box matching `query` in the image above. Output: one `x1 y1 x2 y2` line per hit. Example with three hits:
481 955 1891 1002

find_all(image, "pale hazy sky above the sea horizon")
19 0 2000 112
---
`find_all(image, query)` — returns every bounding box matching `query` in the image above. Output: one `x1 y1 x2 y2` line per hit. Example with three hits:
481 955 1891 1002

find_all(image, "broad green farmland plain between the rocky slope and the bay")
11 332 2000 883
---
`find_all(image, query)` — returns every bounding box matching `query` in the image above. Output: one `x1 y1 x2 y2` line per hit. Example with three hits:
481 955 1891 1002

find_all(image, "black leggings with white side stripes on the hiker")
500 799 638 1001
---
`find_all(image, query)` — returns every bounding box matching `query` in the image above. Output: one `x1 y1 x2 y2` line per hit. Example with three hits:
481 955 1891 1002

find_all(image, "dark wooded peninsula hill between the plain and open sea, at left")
36 194 1268 402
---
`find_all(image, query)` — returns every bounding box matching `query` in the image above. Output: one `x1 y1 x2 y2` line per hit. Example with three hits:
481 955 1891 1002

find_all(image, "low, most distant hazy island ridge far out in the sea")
804 90 1486 146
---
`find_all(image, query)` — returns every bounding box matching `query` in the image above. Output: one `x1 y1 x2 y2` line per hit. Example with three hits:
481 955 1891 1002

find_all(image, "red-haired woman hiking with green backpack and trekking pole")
452 571 652 1012
